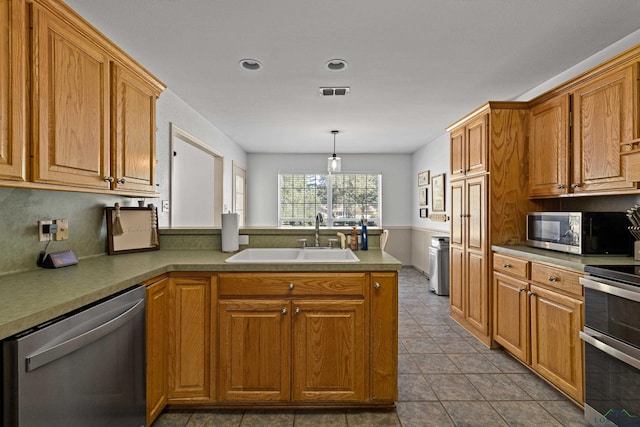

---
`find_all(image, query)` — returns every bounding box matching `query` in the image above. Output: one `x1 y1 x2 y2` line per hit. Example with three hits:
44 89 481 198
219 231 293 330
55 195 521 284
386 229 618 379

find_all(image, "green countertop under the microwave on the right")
491 245 640 271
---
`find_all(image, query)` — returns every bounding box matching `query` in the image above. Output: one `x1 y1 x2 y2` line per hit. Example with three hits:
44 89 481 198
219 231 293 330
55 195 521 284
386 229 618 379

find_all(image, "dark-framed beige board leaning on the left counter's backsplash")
105 207 160 255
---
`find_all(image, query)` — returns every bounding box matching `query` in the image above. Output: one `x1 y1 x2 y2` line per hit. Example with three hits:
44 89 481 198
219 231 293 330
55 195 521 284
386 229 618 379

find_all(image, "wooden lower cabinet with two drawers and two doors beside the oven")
493 254 584 404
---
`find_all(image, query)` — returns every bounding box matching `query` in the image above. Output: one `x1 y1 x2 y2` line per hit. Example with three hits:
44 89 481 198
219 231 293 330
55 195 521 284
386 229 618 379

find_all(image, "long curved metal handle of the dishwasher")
26 299 144 372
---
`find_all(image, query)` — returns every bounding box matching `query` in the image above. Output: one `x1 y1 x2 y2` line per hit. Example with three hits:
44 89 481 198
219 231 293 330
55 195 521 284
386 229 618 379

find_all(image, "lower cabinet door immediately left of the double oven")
530 285 584 402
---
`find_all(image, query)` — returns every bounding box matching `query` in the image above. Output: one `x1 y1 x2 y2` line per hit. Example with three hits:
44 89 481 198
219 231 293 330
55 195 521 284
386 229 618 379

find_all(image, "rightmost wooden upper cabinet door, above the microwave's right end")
571 67 638 192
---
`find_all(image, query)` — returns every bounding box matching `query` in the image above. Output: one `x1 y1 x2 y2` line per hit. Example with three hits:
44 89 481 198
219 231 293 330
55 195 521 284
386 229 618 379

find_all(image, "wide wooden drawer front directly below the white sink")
218 273 366 297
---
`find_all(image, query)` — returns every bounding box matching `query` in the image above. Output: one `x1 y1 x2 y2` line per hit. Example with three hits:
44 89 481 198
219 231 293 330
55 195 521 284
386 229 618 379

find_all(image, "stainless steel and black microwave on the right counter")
527 212 633 255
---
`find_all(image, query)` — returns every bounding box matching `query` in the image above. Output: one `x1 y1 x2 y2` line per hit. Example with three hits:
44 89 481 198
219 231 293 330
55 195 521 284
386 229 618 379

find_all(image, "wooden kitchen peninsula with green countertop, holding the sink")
0 230 401 423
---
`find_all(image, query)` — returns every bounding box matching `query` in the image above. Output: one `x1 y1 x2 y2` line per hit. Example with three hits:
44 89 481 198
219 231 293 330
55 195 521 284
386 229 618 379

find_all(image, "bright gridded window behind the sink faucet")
278 173 382 228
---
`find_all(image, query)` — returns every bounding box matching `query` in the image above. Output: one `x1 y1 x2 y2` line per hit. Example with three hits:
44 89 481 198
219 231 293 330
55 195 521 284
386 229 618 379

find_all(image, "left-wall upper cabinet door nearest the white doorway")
112 63 158 193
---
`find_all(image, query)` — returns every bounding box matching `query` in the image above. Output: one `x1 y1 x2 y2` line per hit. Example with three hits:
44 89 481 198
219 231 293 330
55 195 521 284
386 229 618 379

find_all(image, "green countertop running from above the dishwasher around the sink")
0 249 402 339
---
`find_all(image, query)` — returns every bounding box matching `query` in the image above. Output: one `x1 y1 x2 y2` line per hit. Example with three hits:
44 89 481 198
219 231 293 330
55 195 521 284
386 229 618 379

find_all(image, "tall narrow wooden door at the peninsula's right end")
370 273 398 402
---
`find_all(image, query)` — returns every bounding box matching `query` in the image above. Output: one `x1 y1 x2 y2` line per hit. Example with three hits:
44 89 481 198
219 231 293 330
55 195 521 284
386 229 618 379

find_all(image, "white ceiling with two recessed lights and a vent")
67 0 640 154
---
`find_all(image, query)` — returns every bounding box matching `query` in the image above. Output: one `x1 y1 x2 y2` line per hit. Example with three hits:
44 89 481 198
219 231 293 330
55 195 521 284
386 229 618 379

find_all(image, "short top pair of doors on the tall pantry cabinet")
451 114 488 179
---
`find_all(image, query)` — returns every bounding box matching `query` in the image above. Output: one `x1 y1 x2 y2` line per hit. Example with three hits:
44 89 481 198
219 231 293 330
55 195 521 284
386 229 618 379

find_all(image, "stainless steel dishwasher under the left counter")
2 286 146 427
